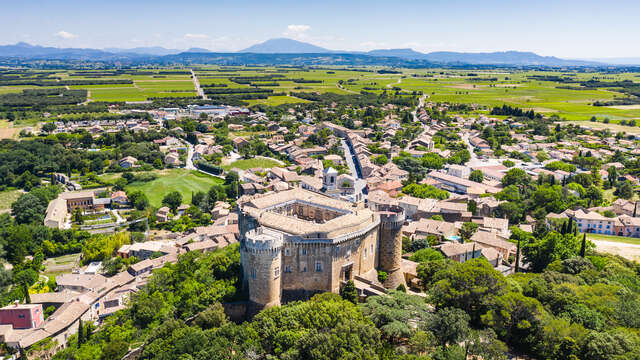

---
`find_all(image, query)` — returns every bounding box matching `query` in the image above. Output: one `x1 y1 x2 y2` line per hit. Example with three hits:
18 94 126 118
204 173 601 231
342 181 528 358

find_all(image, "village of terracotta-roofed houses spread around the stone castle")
0 90 640 349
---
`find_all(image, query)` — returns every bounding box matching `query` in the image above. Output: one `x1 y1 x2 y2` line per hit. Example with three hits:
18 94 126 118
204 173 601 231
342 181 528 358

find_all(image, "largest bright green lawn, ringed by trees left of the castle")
126 169 223 207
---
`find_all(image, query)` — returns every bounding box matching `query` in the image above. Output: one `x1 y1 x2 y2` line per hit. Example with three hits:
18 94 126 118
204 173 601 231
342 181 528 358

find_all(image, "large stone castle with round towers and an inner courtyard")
238 188 405 310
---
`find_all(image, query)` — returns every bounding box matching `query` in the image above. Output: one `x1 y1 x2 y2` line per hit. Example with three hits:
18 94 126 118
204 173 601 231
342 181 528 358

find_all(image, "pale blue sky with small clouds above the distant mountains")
0 0 640 58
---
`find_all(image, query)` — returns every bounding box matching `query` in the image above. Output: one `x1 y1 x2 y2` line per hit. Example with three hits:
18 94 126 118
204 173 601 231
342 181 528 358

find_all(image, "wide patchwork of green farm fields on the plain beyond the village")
0 66 640 120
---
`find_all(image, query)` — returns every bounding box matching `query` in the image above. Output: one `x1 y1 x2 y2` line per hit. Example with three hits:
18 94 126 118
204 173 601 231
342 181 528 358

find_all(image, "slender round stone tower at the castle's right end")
377 205 405 289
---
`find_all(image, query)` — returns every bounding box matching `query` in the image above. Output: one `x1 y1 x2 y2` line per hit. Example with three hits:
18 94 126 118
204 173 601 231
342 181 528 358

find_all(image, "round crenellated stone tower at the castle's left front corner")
240 227 283 312
